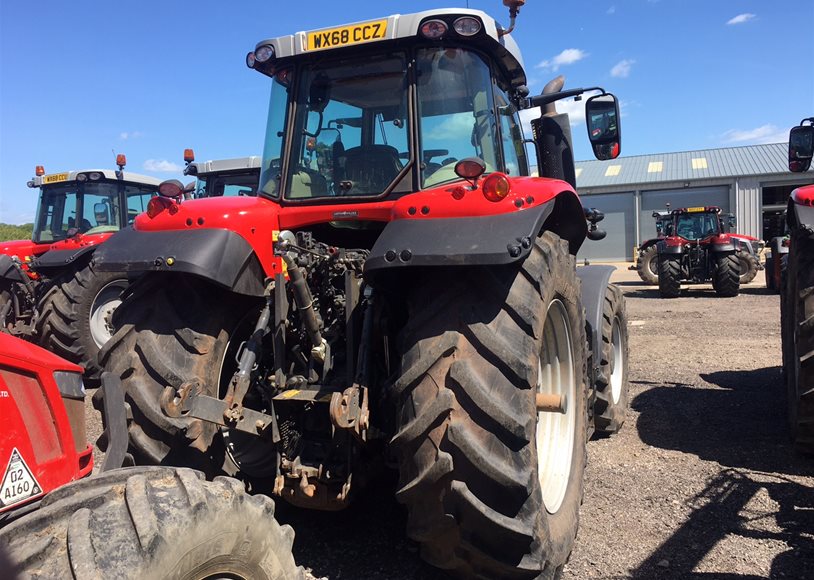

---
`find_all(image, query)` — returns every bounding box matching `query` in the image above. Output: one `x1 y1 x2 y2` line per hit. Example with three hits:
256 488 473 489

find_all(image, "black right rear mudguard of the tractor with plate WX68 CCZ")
365 200 555 277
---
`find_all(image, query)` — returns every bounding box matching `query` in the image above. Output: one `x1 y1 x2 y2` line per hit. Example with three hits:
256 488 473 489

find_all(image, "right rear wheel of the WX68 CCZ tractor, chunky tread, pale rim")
392 232 587 579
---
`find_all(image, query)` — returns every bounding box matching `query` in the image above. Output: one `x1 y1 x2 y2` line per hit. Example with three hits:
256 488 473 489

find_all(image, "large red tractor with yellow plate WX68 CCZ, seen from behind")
94 0 627 578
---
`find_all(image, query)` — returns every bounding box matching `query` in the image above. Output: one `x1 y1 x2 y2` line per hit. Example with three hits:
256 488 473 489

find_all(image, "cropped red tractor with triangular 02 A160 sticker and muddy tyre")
0 334 302 580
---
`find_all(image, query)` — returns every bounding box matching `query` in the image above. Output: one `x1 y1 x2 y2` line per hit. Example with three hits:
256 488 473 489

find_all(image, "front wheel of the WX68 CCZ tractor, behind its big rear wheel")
594 284 628 435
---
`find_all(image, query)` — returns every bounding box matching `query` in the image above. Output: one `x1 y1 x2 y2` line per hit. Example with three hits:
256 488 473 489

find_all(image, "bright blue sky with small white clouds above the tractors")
0 0 814 223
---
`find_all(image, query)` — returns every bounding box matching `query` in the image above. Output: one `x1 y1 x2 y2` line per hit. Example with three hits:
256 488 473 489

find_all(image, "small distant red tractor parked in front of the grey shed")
657 206 740 298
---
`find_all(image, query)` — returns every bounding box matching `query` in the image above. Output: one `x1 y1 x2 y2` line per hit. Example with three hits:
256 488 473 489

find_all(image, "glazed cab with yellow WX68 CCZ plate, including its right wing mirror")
247 9 619 204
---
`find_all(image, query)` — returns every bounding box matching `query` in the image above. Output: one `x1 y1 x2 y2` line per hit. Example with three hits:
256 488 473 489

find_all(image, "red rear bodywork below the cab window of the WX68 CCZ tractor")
133 177 577 276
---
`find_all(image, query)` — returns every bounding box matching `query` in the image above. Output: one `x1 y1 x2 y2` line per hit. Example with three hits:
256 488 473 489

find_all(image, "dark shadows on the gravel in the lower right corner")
631 367 814 580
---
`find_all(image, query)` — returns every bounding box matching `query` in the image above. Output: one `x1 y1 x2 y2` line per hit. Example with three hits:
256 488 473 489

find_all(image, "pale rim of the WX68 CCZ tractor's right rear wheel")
536 300 577 514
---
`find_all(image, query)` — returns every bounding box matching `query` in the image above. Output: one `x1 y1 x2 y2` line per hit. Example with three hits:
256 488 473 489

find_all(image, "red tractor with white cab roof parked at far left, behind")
0 154 160 383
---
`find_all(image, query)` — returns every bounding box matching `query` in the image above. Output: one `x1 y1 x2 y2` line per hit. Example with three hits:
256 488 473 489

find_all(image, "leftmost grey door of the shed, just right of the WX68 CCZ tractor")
577 192 636 262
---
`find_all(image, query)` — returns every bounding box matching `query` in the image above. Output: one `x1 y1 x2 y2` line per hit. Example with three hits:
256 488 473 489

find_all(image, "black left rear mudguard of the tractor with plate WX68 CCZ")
93 228 266 296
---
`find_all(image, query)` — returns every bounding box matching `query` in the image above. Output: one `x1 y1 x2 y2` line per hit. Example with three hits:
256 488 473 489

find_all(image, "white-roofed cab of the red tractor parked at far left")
28 155 160 244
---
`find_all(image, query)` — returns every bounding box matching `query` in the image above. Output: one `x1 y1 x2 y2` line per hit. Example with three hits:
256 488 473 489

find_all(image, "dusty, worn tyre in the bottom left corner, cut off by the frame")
0 467 303 580
